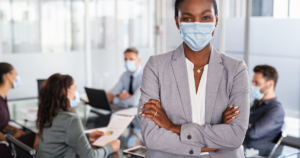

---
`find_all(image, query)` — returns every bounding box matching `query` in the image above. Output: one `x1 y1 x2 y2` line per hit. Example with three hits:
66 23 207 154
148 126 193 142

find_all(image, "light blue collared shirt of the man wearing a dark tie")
110 66 143 107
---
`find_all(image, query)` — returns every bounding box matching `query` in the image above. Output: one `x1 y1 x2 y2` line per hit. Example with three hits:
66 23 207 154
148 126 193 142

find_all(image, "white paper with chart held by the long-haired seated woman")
93 115 134 147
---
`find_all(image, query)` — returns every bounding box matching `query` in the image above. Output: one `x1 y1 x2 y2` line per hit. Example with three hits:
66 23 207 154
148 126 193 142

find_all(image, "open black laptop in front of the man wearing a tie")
84 87 125 112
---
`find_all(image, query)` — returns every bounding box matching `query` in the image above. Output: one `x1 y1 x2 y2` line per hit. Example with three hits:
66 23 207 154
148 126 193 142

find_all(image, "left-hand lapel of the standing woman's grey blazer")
172 44 192 123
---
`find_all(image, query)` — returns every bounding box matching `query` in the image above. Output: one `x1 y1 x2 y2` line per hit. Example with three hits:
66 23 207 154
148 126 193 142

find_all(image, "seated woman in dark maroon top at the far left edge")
0 63 38 157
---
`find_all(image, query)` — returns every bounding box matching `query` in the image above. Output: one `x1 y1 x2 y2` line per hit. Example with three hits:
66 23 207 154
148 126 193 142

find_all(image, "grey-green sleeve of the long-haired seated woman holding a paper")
66 116 113 158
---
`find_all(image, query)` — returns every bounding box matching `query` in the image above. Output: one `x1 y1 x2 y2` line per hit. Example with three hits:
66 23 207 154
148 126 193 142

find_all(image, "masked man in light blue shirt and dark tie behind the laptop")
107 48 143 107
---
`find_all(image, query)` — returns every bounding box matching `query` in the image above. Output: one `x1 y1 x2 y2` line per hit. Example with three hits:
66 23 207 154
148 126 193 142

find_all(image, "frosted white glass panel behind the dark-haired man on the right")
248 18 300 116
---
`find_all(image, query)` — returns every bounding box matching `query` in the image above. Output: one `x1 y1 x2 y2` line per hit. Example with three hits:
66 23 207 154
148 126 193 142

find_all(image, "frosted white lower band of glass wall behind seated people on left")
1 48 155 99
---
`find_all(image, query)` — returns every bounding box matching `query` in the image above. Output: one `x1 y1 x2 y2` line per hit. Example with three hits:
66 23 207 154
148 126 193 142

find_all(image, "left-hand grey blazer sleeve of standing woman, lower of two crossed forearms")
138 56 201 156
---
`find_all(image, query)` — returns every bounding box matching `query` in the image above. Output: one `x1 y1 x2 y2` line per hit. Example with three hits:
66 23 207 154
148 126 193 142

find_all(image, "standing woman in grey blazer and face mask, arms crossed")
139 0 250 158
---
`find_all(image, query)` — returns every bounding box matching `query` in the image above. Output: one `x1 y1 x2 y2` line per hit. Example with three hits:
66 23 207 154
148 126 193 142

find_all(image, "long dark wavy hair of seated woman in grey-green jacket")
36 74 74 140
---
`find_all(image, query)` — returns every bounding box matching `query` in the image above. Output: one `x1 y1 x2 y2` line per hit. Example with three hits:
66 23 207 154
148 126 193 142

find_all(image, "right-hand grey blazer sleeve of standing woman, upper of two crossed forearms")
180 61 250 150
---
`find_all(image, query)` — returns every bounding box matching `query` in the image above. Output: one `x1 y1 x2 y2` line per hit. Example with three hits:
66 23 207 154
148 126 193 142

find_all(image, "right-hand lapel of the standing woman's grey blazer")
205 47 224 124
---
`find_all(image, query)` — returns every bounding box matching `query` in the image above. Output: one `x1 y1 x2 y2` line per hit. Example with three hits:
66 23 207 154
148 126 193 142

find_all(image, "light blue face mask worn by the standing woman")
180 22 215 51
